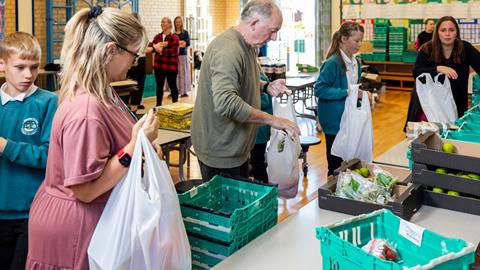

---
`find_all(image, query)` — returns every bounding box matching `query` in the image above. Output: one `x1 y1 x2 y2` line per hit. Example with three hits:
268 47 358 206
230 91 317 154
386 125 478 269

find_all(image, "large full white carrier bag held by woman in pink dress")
88 130 191 270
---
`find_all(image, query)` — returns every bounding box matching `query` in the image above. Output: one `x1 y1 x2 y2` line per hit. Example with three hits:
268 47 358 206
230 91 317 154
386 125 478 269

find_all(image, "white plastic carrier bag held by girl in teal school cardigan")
331 85 373 162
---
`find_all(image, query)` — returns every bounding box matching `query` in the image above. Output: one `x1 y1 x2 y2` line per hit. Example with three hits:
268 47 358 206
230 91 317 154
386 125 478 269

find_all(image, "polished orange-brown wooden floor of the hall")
140 88 410 222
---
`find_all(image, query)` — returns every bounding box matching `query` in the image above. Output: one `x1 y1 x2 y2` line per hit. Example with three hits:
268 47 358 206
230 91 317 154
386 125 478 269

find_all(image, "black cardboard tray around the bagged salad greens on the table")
318 160 422 220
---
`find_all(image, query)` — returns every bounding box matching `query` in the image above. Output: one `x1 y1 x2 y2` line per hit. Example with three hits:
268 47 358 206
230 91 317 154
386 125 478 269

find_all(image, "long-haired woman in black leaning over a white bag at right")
407 16 480 121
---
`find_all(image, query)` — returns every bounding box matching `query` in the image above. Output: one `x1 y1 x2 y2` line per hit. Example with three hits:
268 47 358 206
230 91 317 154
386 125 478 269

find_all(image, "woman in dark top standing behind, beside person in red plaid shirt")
173 16 191 97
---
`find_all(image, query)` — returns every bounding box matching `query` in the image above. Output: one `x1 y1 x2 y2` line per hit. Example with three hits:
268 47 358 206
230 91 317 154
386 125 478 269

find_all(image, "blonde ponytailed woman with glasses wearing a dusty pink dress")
26 7 158 270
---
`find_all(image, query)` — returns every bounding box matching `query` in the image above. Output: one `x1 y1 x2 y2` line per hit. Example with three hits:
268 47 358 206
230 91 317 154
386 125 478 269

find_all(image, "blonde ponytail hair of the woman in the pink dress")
60 6 148 106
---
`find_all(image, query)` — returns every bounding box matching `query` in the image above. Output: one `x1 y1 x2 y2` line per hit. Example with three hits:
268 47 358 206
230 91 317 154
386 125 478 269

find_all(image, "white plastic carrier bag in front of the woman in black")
415 73 458 124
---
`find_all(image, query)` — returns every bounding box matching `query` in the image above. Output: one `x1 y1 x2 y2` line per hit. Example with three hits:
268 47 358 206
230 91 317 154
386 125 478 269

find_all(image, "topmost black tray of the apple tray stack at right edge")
411 132 480 174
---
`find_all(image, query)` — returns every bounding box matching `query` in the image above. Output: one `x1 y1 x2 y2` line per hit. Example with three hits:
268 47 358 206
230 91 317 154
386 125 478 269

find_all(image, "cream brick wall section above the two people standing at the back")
139 0 184 41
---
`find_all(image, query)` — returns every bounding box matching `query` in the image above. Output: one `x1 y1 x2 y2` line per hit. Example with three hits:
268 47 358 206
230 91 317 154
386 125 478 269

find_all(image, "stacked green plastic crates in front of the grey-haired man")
178 175 278 270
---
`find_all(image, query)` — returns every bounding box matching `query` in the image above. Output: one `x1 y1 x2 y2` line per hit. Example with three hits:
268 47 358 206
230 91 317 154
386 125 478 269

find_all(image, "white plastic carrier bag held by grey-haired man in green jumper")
267 96 302 198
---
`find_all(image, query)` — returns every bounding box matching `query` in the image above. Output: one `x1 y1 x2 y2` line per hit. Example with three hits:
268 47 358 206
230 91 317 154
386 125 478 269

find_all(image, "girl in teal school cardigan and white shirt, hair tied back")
315 22 364 175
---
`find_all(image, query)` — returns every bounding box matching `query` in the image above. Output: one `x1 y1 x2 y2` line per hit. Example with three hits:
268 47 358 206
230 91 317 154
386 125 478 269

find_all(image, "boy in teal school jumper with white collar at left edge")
0 32 58 269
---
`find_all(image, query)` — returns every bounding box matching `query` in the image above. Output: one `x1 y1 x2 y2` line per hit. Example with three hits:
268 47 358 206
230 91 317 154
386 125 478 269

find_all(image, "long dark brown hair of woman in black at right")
420 16 465 65
